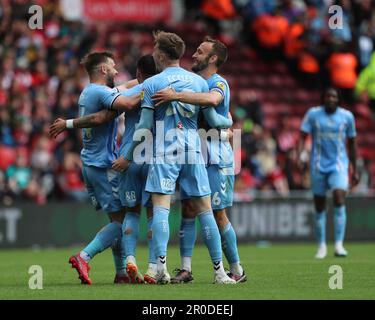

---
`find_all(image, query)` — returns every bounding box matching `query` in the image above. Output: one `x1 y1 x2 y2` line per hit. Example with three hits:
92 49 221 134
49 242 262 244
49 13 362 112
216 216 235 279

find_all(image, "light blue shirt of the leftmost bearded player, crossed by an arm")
78 83 120 168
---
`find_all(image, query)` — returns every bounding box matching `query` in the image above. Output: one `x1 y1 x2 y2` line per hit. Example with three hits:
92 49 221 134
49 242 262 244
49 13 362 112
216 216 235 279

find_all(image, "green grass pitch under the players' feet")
0 243 375 300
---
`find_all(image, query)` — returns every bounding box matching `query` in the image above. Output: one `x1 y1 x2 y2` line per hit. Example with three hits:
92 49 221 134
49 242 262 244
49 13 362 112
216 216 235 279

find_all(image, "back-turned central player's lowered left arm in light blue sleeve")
112 108 154 172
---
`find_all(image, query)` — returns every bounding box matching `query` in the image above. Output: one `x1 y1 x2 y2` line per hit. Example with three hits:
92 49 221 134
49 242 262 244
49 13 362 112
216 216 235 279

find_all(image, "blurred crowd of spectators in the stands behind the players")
0 0 375 204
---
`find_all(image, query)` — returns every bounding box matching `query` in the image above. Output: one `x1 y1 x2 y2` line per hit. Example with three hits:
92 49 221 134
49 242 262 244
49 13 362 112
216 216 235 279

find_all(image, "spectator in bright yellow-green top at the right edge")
355 53 375 119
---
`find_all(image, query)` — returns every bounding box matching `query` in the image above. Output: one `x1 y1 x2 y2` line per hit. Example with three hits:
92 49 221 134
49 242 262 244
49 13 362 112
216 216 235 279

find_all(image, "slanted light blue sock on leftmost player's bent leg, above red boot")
83 222 121 258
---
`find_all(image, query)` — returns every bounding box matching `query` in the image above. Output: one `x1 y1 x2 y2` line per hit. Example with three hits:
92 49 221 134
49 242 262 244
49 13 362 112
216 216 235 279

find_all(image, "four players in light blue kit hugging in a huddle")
50 31 246 284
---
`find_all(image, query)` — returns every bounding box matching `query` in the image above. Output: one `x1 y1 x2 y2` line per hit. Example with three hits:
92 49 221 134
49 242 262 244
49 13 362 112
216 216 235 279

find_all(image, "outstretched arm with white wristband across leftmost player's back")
49 109 117 138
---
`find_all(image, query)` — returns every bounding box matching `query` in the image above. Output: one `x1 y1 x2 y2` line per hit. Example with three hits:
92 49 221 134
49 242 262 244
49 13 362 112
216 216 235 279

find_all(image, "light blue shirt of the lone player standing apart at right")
301 106 356 173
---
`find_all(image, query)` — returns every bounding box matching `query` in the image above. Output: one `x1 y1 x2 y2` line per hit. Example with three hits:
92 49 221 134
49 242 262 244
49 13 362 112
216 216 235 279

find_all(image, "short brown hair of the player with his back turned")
154 30 185 60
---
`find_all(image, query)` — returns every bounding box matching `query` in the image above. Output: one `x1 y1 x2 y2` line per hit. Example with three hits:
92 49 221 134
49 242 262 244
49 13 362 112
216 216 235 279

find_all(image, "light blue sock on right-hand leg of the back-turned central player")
198 209 222 264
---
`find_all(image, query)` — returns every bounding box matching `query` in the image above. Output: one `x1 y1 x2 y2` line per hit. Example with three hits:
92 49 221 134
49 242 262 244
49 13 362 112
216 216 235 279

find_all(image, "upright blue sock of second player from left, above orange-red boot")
122 212 139 257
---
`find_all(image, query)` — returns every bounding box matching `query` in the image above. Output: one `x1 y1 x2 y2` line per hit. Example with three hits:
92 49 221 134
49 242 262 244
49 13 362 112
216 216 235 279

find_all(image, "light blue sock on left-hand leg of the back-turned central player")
152 206 169 257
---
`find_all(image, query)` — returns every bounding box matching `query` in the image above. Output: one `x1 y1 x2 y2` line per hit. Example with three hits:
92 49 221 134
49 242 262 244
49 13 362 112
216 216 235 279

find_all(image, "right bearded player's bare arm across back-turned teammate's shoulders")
152 87 223 107
